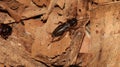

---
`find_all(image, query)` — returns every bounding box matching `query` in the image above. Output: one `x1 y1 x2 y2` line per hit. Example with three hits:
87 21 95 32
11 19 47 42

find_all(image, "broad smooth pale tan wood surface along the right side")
88 2 120 67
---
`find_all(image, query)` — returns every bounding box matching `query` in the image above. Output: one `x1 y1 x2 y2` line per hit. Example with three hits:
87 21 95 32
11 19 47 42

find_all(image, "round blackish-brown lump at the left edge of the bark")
0 23 12 39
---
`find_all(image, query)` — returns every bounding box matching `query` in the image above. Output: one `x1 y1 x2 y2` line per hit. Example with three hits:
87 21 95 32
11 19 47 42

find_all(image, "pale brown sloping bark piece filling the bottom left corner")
0 40 44 67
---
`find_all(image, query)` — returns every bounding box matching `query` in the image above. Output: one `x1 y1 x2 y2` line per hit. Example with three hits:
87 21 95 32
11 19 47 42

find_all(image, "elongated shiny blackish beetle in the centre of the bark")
51 18 77 42
